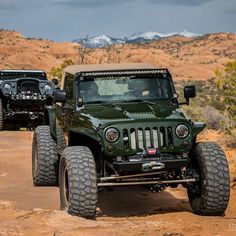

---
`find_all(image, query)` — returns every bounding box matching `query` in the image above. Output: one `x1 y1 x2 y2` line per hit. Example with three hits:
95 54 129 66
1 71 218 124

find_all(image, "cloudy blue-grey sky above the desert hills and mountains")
0 0 236 41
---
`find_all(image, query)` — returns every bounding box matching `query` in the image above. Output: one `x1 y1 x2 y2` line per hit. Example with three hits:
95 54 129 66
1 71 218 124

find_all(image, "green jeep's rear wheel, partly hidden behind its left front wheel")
32 126 59 186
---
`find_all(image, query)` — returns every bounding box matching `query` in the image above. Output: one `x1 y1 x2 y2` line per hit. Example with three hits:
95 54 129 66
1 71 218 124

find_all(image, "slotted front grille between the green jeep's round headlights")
122 127 173 150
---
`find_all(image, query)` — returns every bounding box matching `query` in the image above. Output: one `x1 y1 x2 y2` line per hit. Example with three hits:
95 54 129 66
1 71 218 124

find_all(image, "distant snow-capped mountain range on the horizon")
73 30 201 48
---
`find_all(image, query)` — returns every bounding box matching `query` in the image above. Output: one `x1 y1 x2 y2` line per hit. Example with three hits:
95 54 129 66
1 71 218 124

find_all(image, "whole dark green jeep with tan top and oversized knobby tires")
32 64 230 218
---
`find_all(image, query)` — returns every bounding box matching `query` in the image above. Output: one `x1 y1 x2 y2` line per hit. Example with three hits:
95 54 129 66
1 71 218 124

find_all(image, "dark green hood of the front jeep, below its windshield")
84 102 184 125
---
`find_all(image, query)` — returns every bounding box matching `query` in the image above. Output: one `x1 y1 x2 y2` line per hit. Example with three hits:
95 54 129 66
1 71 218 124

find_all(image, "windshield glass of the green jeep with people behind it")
77 75 173 103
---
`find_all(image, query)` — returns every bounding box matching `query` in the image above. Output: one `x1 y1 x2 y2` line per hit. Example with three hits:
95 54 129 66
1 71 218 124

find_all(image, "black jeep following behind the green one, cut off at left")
0 70 56 130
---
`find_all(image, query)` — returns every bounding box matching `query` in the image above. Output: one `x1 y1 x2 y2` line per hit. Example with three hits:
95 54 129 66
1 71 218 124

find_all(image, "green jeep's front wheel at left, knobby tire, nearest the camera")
59 146 98 219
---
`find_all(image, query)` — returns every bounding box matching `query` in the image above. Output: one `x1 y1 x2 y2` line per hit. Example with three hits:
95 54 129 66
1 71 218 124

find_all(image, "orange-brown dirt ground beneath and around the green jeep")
0 131 236 236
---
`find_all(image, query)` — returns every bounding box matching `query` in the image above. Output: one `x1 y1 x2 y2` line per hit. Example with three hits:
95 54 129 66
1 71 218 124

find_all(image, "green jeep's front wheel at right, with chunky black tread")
188 142 230 216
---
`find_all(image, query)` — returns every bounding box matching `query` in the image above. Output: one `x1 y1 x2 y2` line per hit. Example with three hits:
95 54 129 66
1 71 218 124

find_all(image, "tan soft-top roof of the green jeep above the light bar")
64 63 158 74
